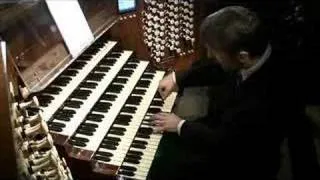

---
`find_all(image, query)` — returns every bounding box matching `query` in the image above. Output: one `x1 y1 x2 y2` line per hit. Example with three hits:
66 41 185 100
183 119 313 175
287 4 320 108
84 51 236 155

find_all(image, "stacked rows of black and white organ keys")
37 38 176 179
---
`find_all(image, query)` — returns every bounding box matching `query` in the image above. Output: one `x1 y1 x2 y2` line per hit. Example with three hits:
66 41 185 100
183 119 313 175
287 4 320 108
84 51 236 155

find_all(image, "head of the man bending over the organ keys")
200 6 268 70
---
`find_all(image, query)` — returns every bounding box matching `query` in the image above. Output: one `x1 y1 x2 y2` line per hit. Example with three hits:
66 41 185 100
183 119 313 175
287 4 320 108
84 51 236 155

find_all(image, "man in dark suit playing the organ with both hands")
153 6 293 179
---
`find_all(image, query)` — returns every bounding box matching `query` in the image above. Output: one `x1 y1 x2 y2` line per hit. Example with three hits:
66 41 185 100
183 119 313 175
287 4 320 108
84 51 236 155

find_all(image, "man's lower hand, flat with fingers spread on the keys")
152 113 182 132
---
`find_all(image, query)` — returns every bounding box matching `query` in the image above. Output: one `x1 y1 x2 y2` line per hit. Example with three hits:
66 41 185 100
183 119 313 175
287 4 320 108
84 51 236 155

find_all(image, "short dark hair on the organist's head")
200 6 269 56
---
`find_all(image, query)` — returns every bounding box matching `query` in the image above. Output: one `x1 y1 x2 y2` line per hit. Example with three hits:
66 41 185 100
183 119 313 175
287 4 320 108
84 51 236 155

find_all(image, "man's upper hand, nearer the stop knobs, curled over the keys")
158 73 177 99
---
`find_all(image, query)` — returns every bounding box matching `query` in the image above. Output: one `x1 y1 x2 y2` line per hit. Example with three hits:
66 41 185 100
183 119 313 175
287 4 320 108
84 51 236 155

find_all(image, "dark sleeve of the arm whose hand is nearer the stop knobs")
175 59 227 88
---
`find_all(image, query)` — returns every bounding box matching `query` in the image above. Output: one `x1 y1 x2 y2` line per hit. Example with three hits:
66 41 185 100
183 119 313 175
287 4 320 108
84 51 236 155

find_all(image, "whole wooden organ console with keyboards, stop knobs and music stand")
0 0 188 180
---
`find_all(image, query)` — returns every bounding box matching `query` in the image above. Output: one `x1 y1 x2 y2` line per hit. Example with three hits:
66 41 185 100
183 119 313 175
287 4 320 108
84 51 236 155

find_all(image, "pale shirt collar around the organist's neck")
240 44 272 81
